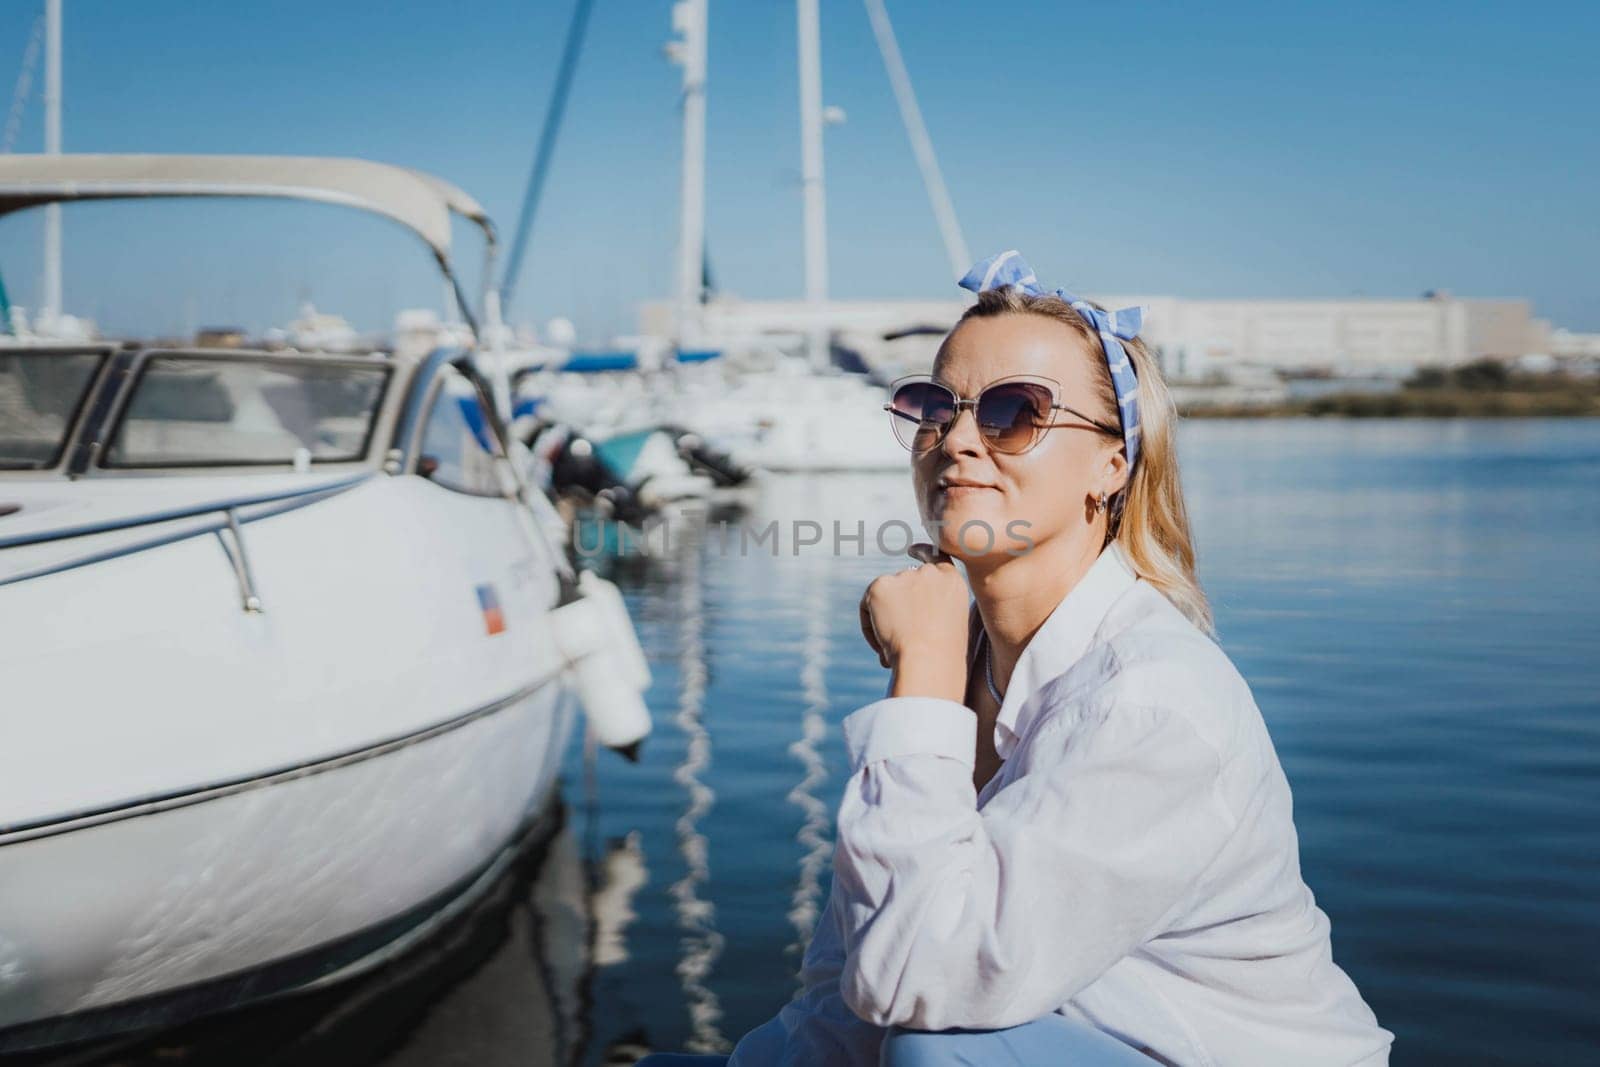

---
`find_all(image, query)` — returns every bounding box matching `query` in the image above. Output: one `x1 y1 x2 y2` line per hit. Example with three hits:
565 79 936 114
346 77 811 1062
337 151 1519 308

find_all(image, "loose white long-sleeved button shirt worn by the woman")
733 547 1394 1067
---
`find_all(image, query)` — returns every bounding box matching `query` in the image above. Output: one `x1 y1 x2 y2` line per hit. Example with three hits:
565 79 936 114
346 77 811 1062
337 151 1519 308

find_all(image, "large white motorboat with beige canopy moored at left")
0 155 648 1053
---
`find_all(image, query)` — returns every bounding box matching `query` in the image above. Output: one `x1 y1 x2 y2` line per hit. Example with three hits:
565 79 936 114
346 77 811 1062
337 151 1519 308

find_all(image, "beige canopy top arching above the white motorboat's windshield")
0 154 496 336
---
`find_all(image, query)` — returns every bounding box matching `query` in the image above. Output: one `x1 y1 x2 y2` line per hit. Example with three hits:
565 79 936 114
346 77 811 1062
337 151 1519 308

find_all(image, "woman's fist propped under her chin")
861 544 971 702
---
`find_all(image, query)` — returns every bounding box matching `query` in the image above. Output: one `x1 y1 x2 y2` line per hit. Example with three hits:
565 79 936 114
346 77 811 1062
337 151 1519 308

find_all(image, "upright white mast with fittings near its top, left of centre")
667 0 707 346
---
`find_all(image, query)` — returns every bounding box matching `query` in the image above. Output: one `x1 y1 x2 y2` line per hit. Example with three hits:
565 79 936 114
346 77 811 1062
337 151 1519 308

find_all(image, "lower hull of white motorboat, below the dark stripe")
0 678 576 1051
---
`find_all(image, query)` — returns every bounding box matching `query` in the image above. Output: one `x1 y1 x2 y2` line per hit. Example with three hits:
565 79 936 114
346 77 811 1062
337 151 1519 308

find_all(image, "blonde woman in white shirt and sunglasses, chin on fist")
643 251 1392 1067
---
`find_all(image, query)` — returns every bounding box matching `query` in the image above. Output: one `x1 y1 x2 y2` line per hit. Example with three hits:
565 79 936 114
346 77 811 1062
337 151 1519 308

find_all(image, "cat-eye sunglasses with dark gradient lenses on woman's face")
883 374 1122 456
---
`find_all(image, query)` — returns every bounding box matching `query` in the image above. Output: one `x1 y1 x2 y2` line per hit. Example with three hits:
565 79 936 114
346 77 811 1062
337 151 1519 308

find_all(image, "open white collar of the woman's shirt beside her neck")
995 542 1138 760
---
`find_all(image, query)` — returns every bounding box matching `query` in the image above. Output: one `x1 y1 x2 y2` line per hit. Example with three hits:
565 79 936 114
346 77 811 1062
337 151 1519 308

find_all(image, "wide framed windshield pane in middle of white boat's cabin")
104 354 389 467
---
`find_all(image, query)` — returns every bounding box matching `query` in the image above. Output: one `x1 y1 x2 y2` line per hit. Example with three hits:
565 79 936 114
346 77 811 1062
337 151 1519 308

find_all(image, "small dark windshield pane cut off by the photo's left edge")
0 349 106 470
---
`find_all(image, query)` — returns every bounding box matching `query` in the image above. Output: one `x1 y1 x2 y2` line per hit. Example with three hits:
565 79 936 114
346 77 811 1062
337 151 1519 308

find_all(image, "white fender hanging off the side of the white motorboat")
552 571 650 755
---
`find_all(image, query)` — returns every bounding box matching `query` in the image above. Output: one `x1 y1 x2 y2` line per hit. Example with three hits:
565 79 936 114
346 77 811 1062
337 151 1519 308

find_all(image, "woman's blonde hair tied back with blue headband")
957 286 1214 633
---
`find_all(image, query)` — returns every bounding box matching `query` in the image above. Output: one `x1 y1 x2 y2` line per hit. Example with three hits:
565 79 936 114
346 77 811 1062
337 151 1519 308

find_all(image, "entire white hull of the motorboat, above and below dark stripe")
0 475 578 1051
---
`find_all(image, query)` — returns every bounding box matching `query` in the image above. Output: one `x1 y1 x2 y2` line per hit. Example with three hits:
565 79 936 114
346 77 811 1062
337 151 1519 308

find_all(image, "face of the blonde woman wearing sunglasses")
912 314 1126 561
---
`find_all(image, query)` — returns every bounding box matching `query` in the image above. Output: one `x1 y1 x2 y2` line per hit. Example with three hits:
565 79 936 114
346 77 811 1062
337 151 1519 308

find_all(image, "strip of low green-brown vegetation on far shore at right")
1179 360 1600 419
